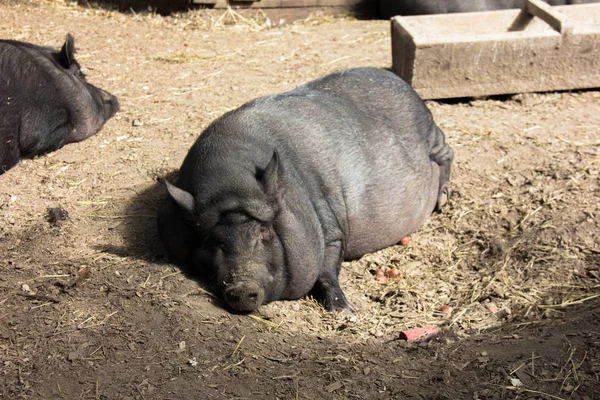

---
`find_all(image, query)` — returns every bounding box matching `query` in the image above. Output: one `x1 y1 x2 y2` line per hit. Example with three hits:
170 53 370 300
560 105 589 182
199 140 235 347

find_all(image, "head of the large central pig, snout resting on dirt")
167 152 286 312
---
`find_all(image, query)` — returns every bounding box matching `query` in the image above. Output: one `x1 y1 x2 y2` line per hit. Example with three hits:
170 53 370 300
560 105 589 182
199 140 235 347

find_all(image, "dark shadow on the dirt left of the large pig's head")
97 170 217 290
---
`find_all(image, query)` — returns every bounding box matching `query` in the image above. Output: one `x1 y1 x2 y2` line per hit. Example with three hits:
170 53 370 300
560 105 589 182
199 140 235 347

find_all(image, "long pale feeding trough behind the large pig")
392 4 600 99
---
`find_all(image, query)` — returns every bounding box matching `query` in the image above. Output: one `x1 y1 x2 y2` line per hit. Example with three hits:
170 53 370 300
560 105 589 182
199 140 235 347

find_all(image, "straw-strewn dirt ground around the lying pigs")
0 0 600 400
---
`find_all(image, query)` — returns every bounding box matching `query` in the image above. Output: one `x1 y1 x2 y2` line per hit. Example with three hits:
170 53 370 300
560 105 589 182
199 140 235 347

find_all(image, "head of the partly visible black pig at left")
52 34 120 143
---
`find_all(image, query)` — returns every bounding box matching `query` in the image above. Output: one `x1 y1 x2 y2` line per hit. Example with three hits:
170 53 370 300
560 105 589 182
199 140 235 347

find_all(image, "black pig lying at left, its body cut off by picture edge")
0 34 119 174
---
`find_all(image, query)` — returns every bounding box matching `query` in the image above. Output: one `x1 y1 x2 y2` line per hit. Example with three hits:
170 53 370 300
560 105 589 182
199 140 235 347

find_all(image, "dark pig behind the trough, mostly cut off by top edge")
379 0 600 18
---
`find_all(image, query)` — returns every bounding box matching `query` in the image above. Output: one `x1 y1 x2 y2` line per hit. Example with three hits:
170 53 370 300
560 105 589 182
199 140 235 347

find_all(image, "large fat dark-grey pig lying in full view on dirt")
158 68 453 312
